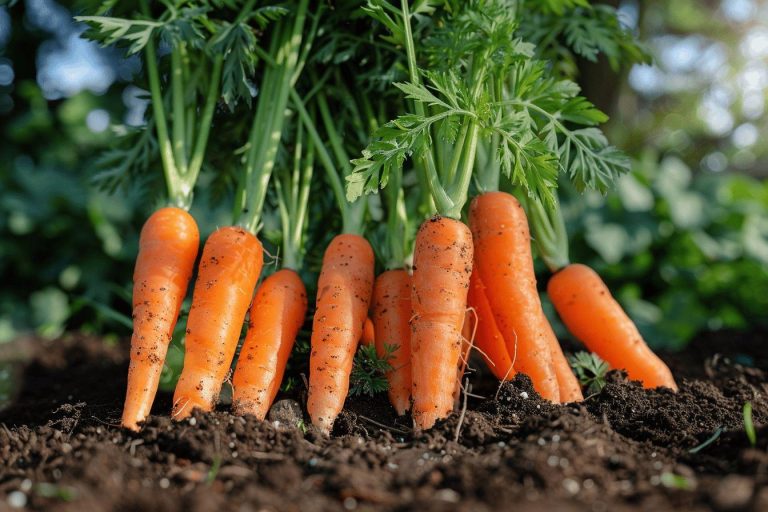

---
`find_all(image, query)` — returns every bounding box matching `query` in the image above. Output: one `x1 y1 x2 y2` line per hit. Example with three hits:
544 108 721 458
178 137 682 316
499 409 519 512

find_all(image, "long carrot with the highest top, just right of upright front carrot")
469 192 560 402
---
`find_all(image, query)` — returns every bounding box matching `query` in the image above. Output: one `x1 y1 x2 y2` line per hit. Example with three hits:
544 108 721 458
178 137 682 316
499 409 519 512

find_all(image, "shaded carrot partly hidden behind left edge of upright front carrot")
372 270 411 416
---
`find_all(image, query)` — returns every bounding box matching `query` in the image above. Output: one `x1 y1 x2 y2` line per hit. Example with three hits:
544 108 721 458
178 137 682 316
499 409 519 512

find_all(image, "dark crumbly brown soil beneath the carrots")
0 333 768 512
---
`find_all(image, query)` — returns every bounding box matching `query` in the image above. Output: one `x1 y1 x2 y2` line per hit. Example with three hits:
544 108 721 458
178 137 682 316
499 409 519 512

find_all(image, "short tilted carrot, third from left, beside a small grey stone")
232 269 307 420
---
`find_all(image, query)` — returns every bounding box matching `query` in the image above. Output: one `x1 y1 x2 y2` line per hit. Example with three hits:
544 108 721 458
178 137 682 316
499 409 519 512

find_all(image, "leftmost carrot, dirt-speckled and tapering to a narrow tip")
122 207 200 430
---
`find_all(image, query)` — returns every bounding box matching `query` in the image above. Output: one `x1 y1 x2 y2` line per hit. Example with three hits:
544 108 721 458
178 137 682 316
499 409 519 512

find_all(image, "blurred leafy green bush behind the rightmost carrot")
563 150 768 349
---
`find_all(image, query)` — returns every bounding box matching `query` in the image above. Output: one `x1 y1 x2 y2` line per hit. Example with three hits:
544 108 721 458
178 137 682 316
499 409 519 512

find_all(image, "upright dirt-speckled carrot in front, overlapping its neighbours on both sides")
411 216 473 429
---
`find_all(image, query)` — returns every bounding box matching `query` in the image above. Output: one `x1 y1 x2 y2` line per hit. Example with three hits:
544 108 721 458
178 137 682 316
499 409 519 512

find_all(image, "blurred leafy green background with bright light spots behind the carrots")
0 0 768 356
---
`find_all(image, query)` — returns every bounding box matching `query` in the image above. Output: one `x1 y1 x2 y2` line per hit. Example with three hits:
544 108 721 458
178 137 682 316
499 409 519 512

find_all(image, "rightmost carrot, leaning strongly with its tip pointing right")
547 263 677 390
